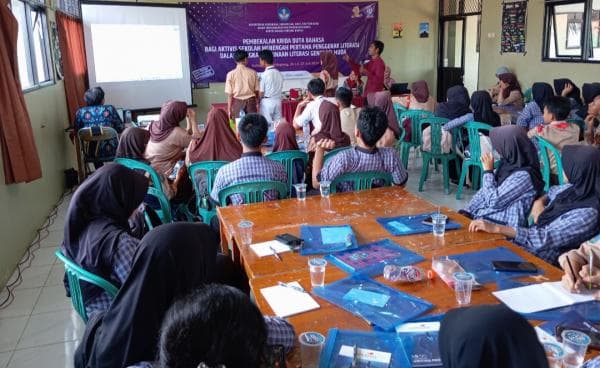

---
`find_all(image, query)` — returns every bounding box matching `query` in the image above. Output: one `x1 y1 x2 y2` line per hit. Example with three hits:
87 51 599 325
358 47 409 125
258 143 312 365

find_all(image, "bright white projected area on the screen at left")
90 24 183 83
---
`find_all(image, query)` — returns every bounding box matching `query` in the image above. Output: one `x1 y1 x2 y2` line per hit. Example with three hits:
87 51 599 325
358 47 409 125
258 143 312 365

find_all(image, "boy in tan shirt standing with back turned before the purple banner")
225 50 260 119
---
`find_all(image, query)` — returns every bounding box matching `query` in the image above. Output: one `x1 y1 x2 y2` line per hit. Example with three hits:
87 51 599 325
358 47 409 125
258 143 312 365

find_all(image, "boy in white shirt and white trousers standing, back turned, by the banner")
258 50 283 130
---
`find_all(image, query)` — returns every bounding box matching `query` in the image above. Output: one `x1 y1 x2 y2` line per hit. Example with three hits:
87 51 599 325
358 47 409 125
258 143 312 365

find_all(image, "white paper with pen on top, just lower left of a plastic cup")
260 281 320 317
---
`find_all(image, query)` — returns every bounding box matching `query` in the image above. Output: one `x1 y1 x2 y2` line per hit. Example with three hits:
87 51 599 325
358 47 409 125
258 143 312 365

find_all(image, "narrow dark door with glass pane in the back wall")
437 17 466 102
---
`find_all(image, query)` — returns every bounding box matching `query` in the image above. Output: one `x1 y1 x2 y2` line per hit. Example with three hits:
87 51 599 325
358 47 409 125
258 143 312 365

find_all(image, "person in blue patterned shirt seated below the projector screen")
75 87 124 167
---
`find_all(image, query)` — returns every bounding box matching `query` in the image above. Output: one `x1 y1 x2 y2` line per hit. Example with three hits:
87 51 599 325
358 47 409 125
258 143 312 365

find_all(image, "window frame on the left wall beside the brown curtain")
11 0 56 93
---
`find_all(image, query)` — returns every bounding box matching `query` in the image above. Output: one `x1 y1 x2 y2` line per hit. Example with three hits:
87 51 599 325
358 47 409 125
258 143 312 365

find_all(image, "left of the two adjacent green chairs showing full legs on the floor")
419 118 460 194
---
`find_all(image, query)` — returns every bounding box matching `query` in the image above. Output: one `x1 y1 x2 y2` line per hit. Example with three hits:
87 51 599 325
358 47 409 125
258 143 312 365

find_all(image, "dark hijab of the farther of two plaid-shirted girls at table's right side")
490 125 544 195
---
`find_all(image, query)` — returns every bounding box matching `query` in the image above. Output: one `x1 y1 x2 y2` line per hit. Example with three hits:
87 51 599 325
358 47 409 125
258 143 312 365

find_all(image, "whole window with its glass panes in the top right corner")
543 0 600 63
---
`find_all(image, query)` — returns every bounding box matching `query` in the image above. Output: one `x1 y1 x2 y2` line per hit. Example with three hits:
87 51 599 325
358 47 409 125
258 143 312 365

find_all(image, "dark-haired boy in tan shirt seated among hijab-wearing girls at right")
527 96 579 175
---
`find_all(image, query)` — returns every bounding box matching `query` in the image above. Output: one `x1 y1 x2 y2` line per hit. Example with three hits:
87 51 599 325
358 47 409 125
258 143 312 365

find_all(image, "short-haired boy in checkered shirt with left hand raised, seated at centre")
312 107 408 191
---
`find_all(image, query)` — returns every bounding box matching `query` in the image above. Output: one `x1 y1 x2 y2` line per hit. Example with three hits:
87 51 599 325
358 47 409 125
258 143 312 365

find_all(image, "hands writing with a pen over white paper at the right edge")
558 234 600 297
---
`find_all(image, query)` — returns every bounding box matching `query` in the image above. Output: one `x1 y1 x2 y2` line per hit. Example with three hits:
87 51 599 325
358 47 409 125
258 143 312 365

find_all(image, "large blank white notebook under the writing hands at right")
492 281 594 313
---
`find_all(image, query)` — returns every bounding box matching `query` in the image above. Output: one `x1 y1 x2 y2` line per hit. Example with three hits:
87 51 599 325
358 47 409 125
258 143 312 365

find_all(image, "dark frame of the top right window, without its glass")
542 0 600 64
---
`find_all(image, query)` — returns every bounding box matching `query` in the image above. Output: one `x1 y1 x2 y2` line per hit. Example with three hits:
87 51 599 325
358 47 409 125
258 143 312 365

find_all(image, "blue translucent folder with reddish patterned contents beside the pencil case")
325 239 425 276
